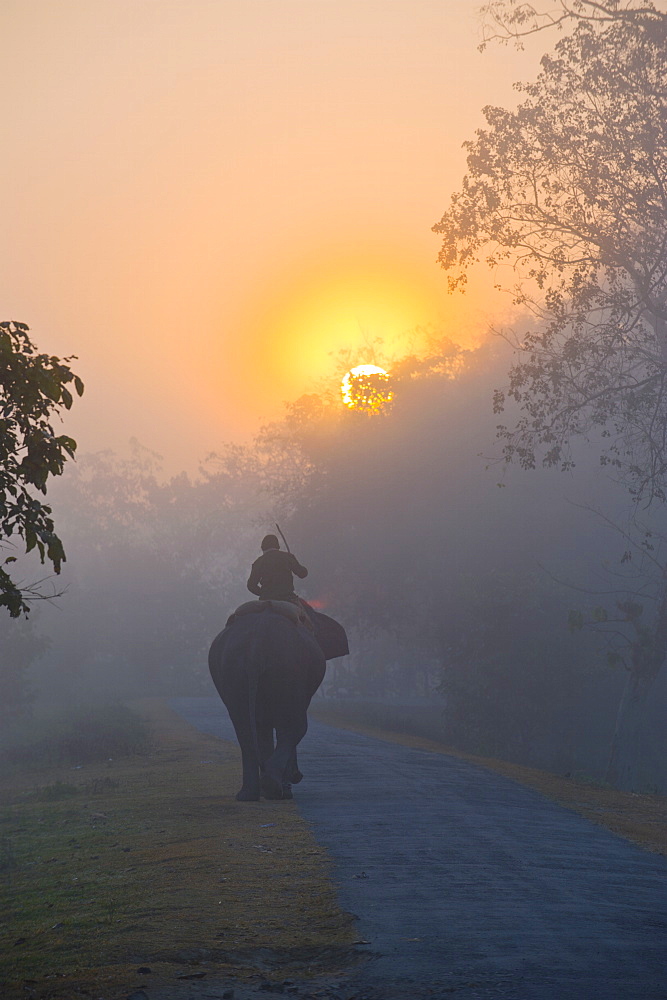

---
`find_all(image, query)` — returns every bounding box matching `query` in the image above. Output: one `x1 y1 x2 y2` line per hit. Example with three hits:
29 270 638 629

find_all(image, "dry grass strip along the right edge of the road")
311 704 667 855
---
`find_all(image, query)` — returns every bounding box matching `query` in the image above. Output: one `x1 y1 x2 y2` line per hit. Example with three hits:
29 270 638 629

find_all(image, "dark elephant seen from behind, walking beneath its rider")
208 601 326 802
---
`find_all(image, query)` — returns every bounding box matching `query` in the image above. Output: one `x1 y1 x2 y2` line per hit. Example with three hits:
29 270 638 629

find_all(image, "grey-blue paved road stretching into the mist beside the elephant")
173 698 667 1000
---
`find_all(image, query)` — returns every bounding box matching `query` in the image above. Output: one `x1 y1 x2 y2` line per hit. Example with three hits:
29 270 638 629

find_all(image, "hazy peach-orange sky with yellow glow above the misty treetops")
0 0 543 470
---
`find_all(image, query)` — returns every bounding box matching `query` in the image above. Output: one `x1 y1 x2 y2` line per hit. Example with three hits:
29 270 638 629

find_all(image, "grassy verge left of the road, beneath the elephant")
0 701 355 1000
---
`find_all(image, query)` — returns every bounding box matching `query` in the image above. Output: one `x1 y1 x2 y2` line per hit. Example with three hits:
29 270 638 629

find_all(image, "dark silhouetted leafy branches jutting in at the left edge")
0 322 83 618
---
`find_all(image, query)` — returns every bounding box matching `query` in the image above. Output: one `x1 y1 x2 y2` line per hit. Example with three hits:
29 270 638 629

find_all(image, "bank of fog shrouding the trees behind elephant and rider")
5 341 667 789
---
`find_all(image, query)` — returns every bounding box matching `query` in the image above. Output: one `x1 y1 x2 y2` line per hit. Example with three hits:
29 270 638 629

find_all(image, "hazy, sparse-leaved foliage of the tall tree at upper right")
434 6 667 501
